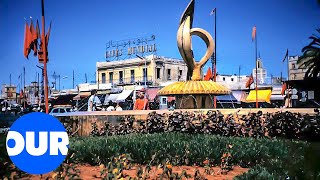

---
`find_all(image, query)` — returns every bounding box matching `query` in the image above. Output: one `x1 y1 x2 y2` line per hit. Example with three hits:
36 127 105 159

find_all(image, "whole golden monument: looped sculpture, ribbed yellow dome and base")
158 0 230 109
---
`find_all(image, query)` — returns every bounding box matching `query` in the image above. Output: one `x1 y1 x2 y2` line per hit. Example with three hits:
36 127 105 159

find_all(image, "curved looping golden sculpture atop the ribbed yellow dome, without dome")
177 0 215 81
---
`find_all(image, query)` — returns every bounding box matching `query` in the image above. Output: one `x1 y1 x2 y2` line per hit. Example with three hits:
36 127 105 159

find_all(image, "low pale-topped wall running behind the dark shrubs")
55 108 315 136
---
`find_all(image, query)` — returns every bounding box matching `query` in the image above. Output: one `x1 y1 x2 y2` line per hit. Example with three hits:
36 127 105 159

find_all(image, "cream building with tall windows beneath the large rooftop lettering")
96 55 187 87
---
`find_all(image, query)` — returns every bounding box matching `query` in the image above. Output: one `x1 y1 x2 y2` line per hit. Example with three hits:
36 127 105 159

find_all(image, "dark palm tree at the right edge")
297 29 320 78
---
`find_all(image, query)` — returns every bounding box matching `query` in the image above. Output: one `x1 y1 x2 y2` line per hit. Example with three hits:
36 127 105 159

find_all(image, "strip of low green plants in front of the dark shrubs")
69 133 316 178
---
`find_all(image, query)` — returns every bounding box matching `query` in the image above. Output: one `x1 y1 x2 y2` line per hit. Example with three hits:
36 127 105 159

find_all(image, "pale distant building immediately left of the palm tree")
288 56 307 80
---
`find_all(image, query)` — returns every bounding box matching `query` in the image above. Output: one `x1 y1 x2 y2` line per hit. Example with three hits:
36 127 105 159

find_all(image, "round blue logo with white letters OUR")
6 112 69 174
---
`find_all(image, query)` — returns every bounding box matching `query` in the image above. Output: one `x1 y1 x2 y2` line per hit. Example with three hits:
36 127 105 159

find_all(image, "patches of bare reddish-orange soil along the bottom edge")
23 165 249 180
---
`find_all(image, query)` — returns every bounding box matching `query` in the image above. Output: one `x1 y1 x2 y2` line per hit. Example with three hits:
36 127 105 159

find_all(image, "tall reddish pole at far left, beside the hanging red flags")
41 0 49 114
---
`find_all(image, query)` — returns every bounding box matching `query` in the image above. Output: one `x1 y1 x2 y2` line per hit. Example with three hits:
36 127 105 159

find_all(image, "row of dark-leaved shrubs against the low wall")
87 111 320 140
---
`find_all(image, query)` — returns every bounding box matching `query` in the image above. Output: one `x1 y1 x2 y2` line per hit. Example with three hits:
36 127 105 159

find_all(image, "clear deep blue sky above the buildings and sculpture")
0 0 320 88
